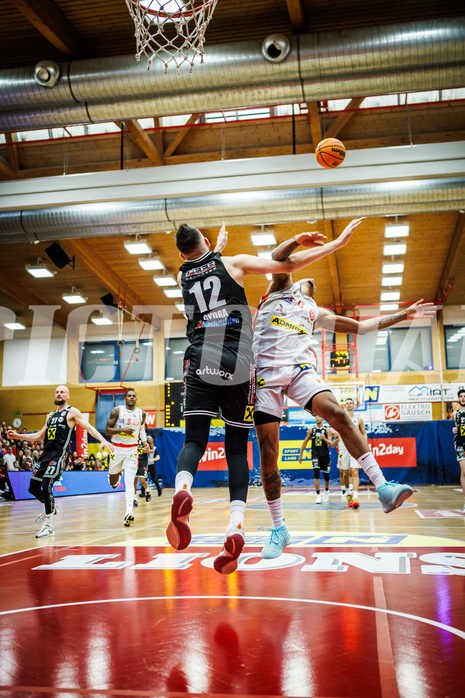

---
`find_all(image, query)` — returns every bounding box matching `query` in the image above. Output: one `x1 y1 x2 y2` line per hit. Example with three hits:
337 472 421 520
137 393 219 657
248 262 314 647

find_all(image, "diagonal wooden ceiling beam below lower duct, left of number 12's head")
64 239 159 329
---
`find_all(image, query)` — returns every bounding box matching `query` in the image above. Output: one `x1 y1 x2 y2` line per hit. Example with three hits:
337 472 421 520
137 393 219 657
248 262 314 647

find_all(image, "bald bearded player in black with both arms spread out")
8 385 113 538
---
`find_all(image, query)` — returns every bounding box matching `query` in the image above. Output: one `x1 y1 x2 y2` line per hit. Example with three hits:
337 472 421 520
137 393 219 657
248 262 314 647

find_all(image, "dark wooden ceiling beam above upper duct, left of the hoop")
15 0 92 58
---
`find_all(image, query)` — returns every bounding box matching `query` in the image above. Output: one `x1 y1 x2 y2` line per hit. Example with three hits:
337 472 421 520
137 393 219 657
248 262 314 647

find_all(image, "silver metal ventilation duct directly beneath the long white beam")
0 177 465 244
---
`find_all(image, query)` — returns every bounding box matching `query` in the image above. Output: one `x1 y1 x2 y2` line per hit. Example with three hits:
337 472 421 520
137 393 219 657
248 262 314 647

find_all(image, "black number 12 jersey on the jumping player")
180 252 253 380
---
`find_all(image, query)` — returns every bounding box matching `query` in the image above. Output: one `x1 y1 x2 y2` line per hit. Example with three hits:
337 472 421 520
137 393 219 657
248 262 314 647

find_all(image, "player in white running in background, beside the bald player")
105 388 147 527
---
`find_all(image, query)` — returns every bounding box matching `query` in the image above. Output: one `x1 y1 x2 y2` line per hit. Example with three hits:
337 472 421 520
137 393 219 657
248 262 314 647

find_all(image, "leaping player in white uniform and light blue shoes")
254 219 436 558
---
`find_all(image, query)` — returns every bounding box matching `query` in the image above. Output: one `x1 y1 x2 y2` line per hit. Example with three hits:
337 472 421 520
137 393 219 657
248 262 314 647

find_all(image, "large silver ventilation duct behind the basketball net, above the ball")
0 17 465 131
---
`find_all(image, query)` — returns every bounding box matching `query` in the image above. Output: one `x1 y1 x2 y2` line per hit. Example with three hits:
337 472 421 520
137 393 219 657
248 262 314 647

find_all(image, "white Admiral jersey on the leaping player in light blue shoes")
253 283 318 368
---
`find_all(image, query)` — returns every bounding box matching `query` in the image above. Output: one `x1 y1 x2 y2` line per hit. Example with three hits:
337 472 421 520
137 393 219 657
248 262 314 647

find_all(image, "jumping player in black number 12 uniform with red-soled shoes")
166 224 358 574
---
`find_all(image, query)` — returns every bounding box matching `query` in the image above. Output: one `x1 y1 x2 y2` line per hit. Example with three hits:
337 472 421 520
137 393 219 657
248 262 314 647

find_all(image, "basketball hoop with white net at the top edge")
126 0 218 75
